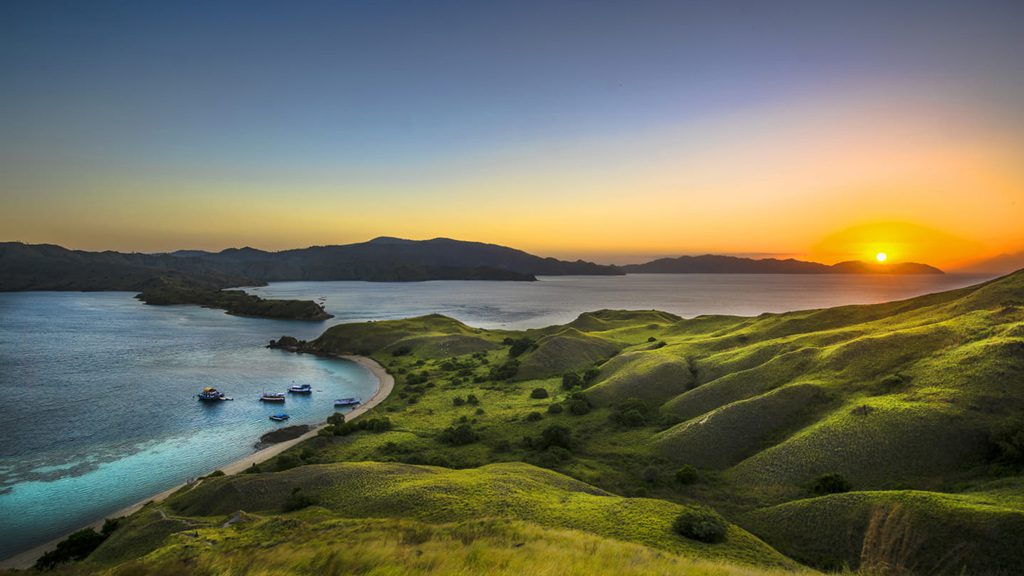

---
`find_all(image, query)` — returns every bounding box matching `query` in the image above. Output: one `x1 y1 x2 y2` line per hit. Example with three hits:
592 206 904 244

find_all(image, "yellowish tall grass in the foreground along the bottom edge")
92 519 814 576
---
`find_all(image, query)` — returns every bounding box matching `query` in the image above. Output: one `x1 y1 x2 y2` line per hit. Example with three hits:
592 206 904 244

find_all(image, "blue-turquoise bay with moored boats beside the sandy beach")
0 292 377 558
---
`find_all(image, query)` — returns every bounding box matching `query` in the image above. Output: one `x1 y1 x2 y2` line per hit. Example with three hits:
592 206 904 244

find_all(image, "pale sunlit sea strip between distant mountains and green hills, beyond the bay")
249 274 990 329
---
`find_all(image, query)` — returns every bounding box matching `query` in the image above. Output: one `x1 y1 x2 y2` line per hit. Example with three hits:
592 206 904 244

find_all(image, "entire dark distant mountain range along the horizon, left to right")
0 237 942 291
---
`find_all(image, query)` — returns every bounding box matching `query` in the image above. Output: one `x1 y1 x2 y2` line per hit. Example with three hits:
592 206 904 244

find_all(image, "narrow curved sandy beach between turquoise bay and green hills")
0 355 394 570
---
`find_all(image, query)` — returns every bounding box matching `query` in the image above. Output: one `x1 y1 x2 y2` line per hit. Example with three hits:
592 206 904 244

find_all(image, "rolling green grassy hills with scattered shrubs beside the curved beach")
32 273 1024 574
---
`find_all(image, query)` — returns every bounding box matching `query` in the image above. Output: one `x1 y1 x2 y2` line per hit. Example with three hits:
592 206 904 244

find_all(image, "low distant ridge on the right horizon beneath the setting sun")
620 254 943 274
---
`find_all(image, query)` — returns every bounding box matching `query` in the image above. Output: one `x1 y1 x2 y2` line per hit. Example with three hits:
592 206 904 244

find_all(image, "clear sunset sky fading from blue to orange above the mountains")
0 0 1024 268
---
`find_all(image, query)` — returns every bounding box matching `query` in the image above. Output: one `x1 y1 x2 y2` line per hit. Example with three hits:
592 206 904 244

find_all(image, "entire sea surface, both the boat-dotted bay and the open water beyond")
0 275 984 559
